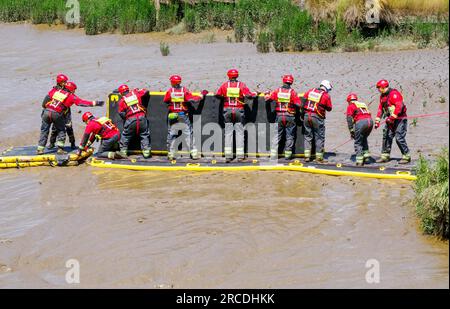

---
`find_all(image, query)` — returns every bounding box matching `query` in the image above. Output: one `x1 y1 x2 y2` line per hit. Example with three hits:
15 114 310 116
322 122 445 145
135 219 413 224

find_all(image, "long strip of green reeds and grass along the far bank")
0 0 449 53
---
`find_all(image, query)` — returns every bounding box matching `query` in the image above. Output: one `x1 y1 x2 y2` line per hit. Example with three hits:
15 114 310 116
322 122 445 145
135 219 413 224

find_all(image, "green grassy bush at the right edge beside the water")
413 148 449 239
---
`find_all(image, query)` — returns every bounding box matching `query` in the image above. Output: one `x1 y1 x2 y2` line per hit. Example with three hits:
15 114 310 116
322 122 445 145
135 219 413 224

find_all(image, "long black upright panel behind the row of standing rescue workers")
107 92 304 154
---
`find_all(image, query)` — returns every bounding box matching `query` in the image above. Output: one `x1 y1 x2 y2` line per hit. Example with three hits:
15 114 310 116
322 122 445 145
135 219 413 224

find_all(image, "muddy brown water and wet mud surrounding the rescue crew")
0 24 449 288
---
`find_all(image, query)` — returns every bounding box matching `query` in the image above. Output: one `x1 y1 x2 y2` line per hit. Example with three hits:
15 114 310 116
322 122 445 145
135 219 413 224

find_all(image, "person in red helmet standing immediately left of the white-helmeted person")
264 75 300 160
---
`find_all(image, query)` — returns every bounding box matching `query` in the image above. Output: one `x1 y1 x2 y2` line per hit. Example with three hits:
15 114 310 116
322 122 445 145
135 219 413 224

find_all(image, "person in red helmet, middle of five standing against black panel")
216 69 258 163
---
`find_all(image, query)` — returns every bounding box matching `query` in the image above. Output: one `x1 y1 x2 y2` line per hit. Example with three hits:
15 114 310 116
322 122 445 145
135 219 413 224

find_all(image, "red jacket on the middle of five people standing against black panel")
216 80 254 109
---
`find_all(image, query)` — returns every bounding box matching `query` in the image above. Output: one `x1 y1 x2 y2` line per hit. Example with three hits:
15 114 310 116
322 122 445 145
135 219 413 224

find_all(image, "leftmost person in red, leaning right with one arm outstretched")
37 82 104 155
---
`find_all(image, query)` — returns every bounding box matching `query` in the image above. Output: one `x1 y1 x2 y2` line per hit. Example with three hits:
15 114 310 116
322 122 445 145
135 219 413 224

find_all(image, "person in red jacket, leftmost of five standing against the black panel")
119 85 152 159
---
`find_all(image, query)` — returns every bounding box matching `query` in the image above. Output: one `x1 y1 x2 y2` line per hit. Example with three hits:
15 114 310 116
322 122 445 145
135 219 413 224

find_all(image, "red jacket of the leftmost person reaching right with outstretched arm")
42 88 95 113
